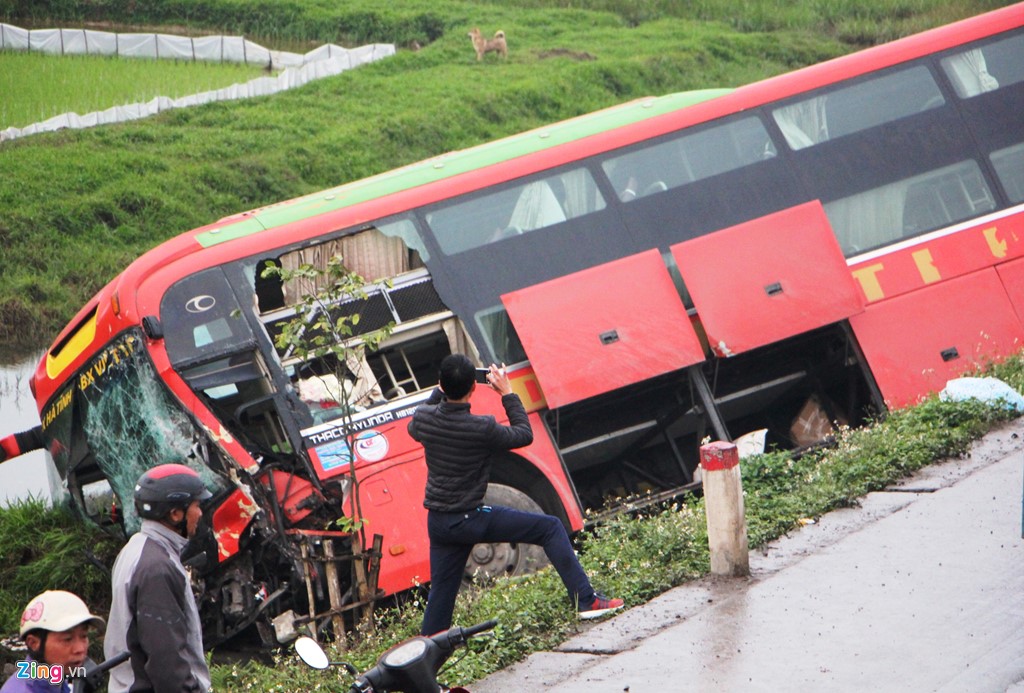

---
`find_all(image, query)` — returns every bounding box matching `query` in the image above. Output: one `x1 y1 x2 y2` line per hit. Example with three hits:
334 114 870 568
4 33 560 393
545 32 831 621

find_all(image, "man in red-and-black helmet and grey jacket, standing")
103 458 210 693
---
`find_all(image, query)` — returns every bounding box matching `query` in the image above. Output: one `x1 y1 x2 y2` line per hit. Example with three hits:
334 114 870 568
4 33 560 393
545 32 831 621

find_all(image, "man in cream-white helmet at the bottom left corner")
0 590 104 693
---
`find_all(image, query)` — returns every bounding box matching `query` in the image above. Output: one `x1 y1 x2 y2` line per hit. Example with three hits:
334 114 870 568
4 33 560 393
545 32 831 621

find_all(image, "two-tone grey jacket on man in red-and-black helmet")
103 520 210 693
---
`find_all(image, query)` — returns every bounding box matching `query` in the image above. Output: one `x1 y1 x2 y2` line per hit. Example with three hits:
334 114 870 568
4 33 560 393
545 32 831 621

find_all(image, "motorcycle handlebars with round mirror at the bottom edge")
295 619 498 693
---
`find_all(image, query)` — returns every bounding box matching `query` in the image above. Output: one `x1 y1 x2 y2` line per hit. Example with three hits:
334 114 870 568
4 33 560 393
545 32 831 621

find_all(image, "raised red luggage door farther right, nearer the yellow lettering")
671 201 864 356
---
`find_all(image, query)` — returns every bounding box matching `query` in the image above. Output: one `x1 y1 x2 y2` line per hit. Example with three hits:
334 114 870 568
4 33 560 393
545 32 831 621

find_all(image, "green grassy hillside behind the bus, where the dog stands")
0 0 999 356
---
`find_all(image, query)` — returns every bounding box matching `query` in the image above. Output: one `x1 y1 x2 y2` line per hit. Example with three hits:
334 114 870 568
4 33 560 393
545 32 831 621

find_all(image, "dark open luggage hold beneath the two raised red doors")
546 323 885 509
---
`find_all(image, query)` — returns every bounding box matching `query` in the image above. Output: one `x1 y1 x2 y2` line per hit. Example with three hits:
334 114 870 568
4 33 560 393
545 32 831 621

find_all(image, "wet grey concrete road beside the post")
469 420 1024 693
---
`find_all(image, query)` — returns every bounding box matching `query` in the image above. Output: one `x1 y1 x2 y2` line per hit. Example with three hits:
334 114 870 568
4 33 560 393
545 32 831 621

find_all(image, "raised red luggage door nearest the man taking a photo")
502 250 705 407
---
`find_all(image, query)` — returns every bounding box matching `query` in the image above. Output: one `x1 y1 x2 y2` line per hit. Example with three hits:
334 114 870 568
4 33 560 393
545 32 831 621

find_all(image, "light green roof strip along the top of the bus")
196 89 731 248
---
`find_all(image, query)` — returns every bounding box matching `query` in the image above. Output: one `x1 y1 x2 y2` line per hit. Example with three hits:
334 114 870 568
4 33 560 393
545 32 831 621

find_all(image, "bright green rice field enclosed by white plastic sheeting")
0 50 266 130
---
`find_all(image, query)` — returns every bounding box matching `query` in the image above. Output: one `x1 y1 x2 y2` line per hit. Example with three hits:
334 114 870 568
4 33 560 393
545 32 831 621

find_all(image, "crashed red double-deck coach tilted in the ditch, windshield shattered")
6 4 1024 646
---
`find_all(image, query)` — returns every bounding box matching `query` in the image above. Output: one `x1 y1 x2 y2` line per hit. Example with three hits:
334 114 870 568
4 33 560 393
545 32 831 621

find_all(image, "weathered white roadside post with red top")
700 441 751 577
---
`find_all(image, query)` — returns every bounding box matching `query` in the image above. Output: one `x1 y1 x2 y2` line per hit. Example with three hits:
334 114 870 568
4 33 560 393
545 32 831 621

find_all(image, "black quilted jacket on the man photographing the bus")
409 389 534 513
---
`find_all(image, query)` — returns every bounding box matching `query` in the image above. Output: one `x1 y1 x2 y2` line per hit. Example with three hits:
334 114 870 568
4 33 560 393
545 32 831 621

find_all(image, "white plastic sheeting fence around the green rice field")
0 23 395 142
